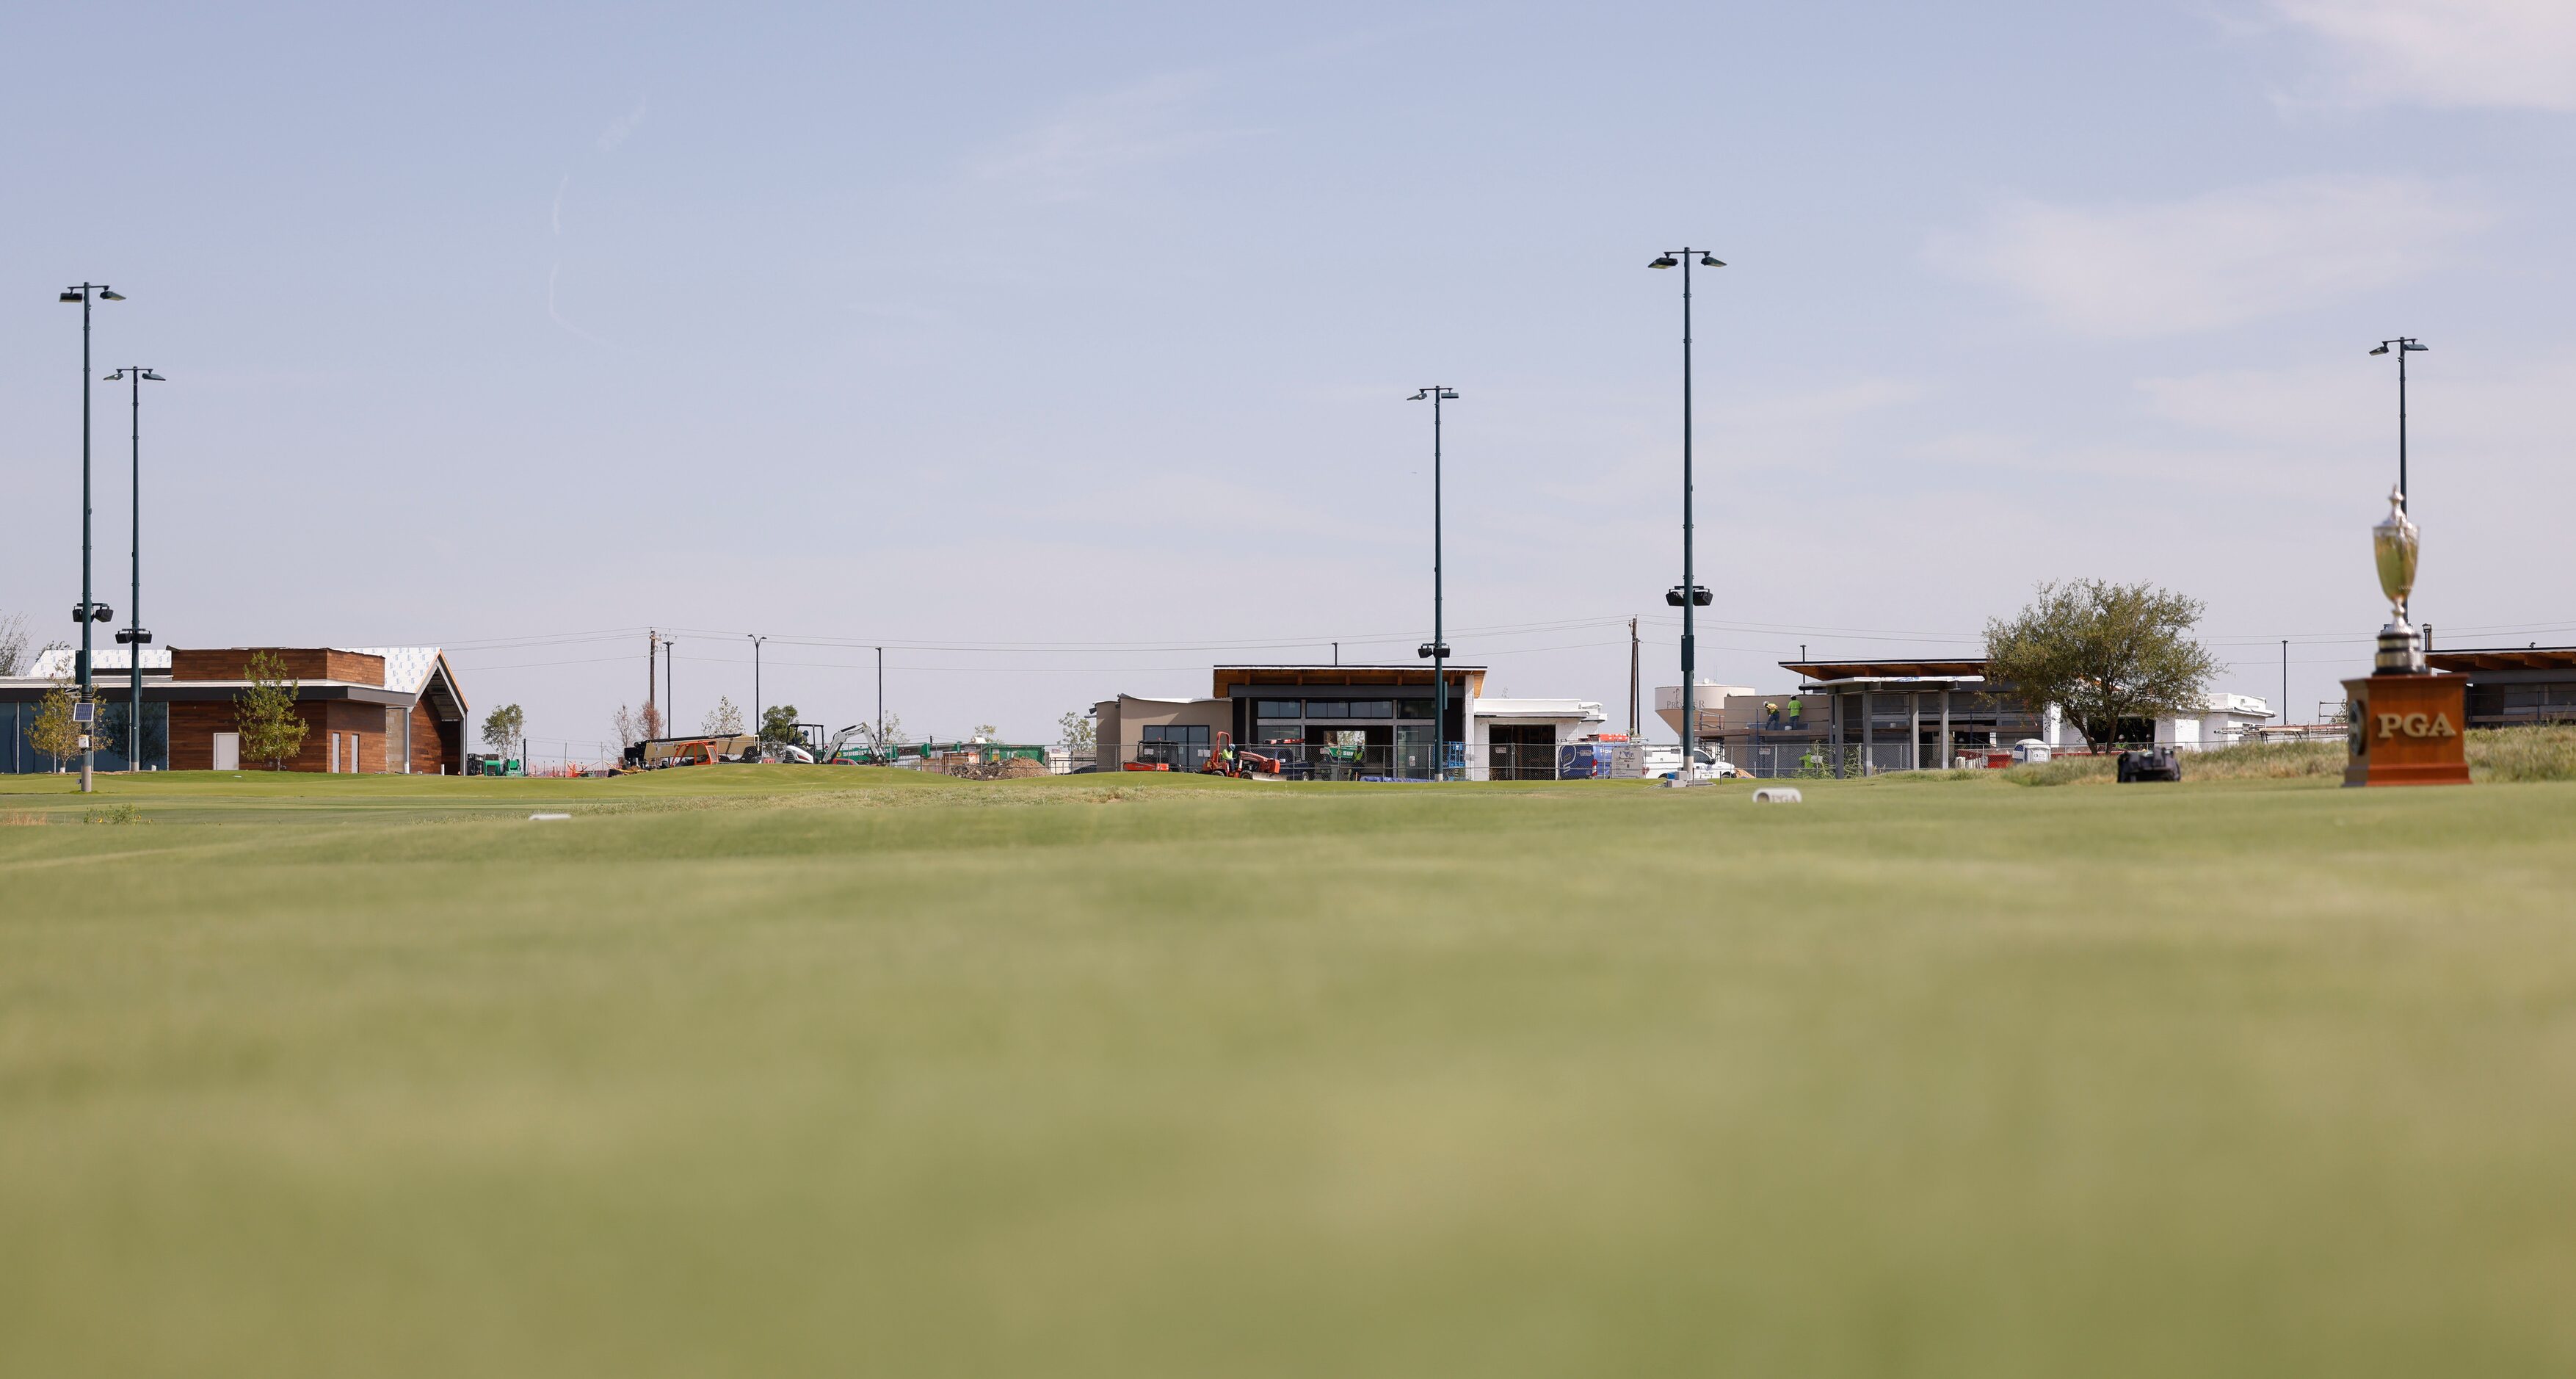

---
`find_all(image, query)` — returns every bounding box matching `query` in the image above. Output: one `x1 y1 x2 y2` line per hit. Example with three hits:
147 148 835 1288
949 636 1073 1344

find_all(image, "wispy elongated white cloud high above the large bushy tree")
1929 178 2494 335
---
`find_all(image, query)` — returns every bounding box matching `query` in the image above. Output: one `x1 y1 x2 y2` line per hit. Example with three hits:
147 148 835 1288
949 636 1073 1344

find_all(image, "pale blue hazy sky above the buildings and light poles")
0 0 2576 758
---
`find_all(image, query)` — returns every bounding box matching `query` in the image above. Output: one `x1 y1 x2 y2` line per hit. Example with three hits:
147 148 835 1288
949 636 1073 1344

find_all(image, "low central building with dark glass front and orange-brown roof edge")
1092 665 1608 781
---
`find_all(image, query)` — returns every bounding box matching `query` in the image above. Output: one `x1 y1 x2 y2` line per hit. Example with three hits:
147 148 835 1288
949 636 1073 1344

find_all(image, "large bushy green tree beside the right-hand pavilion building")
1986 580 2218 750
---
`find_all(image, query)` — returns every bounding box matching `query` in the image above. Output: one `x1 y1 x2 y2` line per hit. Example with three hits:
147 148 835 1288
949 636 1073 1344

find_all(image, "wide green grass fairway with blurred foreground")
0 768 2576 1379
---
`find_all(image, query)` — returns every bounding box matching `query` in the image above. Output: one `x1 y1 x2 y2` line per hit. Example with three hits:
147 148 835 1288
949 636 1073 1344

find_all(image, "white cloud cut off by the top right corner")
2272 0 2576 111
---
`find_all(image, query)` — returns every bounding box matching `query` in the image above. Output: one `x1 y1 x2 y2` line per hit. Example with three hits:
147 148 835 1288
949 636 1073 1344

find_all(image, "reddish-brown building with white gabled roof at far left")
0 647 466 776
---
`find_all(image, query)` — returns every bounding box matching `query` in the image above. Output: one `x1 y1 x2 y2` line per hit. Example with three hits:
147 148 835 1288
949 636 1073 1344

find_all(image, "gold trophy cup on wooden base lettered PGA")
2349 490 2468 786
